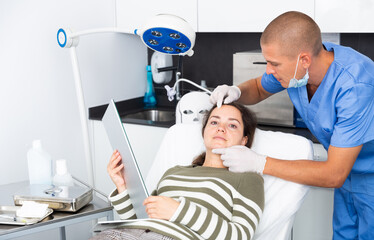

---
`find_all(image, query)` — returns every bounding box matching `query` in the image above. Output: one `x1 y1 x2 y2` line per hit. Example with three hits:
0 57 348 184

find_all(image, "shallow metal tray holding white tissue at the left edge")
0 206 53 225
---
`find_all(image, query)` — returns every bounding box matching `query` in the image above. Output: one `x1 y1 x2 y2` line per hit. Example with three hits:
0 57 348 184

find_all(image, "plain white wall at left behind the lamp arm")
0 0 147 184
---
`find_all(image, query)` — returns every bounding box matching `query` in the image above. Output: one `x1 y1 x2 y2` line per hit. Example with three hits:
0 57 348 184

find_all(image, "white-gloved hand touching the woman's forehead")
210 84 241 108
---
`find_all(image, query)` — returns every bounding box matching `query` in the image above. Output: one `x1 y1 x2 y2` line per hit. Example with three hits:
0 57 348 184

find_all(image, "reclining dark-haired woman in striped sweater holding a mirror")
94 103 264 240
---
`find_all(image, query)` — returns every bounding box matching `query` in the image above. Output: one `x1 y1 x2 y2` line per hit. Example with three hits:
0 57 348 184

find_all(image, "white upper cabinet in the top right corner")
315 0 374 33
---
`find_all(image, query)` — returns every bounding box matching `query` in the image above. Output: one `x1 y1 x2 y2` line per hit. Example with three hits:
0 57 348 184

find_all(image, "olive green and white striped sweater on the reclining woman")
109 166 264 240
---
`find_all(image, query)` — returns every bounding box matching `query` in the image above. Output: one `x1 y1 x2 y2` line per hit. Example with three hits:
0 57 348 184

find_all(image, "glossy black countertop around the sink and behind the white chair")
88 97 319 143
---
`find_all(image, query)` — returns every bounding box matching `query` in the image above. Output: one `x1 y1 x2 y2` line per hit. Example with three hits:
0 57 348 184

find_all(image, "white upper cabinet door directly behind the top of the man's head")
198 0 314 32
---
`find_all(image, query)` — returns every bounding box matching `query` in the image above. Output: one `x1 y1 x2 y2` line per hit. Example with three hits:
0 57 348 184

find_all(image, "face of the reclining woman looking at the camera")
204 105 248 150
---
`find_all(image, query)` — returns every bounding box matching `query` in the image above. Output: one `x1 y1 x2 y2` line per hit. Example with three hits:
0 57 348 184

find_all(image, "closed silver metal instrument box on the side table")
13 184 93 212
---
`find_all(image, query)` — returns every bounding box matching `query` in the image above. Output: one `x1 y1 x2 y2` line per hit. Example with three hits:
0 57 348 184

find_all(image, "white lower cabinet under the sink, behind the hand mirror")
91 121 167 194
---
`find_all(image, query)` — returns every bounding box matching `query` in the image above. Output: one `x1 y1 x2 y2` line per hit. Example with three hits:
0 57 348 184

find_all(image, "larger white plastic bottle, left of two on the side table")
27 140 52 185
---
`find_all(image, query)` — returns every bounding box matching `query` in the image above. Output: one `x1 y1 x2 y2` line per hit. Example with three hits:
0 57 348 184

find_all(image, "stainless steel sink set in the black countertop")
122 109 175 122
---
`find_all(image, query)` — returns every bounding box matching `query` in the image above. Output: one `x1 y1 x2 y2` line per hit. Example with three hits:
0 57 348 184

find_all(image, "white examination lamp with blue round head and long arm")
57 14 196 186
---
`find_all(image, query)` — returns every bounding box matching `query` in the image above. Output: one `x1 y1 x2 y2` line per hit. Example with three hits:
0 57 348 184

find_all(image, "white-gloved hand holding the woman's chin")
212 145 266 175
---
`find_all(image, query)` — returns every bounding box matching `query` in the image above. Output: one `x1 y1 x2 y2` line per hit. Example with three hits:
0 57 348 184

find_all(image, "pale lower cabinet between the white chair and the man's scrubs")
292 144 334 240
